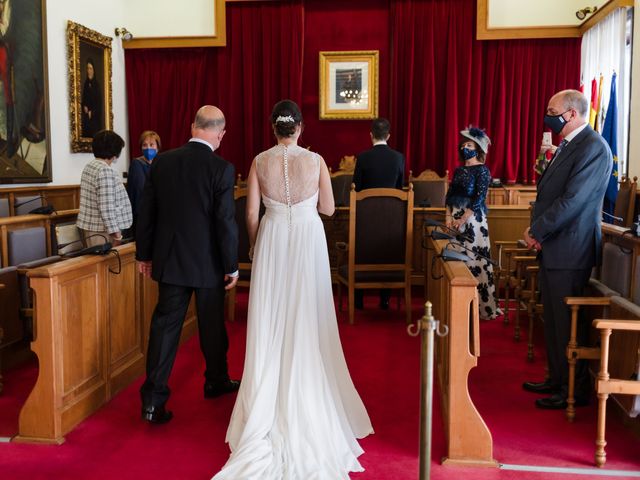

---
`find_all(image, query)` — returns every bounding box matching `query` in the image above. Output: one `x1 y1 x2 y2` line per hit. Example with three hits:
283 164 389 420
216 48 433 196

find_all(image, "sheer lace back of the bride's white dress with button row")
256 144 320 205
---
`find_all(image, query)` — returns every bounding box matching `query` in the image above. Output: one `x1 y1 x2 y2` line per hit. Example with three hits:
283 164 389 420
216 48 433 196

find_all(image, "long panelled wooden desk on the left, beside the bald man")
14 244 196 444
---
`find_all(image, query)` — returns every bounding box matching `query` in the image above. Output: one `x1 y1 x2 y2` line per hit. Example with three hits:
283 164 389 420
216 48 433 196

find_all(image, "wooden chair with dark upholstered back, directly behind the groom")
336 184 413 324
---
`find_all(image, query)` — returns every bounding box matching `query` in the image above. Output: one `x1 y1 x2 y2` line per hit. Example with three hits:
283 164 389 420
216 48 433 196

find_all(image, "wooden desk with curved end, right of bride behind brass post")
425 231 498 467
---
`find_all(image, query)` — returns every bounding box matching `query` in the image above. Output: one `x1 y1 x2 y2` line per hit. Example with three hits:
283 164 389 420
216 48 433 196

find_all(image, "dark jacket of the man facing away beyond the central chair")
353 145 404 191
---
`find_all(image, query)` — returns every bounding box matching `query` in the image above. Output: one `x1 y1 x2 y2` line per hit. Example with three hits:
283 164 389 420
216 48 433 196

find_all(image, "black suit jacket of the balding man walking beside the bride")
136 142 238 288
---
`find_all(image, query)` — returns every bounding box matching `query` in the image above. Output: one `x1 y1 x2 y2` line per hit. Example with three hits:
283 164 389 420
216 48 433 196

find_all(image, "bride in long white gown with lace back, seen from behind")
213 100 373 480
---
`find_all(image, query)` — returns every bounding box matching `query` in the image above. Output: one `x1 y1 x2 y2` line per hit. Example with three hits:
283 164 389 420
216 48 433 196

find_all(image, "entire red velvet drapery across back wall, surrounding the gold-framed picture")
125 0 580 182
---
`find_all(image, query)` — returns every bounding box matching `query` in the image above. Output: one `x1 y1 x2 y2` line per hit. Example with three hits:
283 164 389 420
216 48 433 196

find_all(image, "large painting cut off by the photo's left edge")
0 0 51 183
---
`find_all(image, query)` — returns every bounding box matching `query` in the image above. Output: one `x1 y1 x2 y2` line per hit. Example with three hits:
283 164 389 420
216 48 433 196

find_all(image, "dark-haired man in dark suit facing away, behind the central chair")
353 118 404 310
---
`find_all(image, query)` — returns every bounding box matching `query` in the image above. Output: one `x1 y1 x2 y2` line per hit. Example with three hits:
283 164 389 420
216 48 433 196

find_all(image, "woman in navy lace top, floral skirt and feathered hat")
445 126 502 320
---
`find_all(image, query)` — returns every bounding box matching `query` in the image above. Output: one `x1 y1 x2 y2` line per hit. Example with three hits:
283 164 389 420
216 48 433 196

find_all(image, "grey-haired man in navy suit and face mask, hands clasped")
523 90 613 409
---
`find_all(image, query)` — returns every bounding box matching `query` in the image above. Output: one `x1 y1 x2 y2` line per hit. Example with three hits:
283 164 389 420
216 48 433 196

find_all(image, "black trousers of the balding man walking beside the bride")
140 283 229 406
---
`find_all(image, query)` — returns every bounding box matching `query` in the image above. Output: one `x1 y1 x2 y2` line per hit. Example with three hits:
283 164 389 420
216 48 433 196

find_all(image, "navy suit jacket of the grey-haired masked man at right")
530 126 613 270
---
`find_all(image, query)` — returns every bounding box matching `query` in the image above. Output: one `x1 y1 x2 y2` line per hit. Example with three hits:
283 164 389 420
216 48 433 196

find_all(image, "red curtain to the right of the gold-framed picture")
390 0 580 183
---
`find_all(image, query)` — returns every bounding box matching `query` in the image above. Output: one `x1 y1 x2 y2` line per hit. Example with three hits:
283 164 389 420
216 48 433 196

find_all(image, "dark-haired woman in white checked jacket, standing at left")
76 130 132 247
